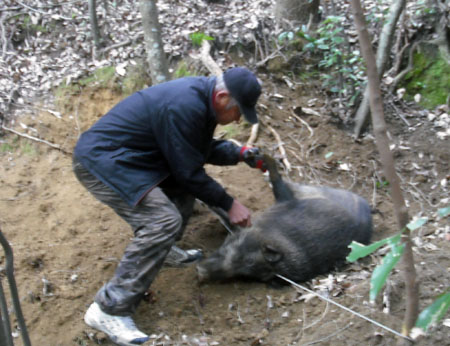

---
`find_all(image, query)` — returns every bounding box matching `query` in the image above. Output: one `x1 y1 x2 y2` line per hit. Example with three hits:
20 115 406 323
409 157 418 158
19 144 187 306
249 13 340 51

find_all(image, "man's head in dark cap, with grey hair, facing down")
213 67 261 125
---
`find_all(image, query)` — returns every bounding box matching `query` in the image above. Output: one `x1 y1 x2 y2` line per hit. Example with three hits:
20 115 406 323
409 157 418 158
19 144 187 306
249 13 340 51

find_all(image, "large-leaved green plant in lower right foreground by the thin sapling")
347 206 450 331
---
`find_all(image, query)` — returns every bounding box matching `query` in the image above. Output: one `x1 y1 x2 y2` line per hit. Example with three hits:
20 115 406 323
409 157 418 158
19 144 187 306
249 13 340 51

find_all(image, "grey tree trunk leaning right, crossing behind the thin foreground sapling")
354 0 406 137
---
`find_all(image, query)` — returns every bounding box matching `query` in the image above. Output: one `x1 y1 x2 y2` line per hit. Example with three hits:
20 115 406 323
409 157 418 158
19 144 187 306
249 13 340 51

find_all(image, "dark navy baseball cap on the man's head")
223 67 261 124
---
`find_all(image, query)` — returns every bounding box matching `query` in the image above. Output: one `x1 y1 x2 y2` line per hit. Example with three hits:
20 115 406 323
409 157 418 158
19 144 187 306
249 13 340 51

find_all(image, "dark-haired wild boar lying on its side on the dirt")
197 155 372 282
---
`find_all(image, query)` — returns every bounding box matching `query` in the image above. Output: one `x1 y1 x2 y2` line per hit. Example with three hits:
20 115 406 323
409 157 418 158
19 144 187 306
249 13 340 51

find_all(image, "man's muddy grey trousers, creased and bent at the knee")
73 159 195 316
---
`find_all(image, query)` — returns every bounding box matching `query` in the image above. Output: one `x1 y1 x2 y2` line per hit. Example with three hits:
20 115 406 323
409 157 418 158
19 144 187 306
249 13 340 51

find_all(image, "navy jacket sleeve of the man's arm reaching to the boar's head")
155 107 233 210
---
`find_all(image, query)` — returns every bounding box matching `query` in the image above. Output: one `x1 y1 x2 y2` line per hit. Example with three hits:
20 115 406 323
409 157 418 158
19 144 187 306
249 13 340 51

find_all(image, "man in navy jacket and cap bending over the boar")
73 67 261 345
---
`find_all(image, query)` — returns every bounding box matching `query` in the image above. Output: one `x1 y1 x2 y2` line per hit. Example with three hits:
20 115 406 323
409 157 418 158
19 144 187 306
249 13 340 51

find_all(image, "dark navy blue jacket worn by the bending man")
74 77 239 210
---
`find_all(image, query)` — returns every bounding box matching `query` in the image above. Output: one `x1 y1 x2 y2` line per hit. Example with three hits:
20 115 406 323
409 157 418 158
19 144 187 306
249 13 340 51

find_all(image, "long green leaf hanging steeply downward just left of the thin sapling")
370 244 405 302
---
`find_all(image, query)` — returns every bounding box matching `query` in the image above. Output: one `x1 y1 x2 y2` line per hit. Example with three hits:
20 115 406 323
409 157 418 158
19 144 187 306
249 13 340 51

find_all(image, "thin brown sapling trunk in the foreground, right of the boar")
351 0 419 335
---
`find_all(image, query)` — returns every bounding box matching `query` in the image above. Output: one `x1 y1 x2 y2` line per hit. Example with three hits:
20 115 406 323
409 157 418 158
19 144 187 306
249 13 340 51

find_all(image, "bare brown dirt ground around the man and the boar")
0 76 450 346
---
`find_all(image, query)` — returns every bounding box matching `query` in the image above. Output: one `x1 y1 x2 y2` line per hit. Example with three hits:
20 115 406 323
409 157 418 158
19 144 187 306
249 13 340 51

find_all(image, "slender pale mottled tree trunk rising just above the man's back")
140 0 170 84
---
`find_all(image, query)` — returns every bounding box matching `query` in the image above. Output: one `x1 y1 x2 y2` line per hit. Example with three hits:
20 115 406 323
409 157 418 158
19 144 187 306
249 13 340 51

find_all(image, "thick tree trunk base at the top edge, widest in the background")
275 0 320 25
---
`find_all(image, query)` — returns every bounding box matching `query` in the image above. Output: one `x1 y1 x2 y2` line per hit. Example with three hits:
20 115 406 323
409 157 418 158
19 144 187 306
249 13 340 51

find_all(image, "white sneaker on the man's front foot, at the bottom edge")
84 302 150 346
